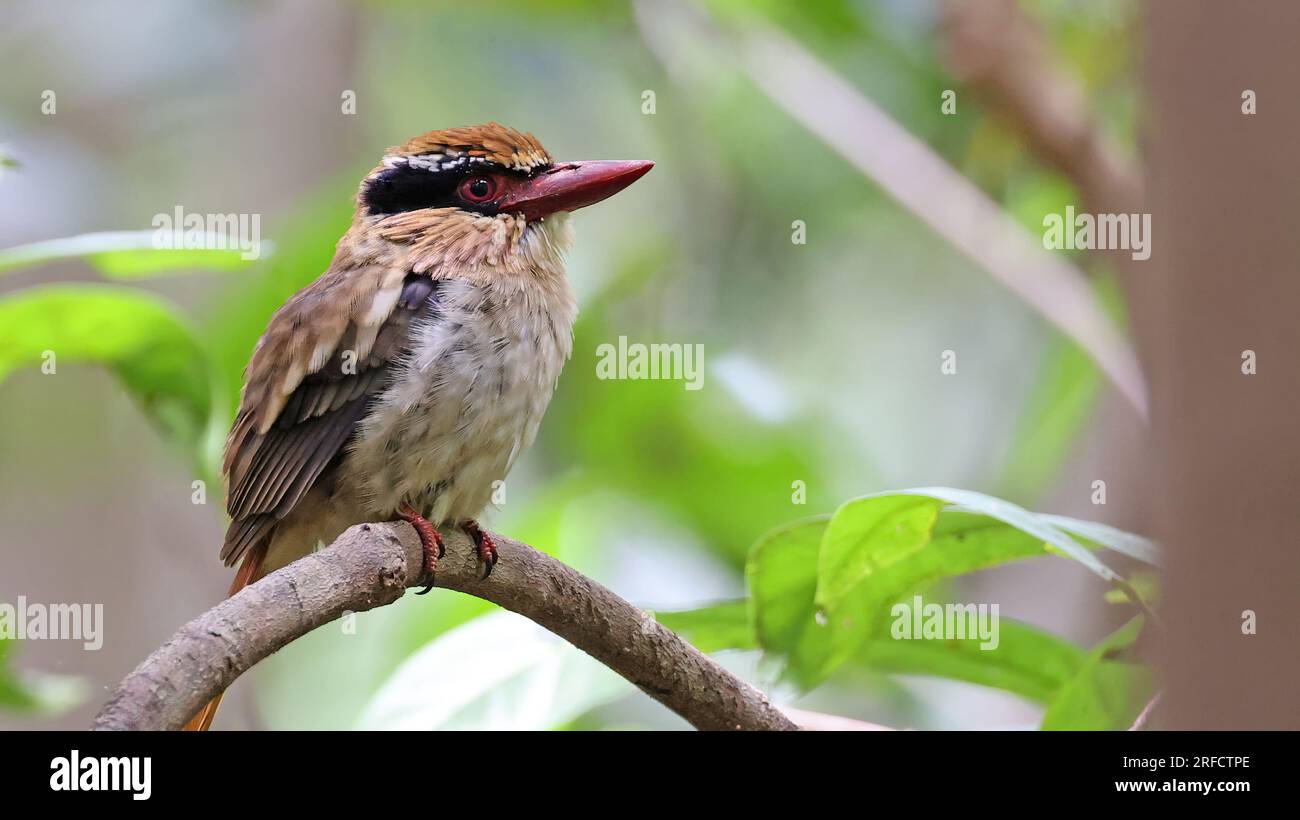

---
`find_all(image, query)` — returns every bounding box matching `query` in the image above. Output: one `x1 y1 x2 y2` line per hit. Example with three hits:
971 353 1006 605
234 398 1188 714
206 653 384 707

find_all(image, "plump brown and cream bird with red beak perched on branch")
186 122 654 730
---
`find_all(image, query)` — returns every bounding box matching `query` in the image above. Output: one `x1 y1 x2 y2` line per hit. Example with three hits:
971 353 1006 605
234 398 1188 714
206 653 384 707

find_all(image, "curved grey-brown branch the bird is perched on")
94 524 798 729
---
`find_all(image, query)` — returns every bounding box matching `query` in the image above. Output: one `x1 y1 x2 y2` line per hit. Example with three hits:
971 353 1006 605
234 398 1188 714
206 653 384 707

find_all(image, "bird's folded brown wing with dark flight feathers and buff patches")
221 268 437 565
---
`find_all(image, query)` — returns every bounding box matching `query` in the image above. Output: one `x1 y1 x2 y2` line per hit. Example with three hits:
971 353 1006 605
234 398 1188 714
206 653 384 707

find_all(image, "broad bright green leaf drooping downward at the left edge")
0 285 212 442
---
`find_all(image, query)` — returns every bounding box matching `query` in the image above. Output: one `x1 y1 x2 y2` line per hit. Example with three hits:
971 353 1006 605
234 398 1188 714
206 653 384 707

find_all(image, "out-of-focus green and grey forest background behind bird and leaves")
0 0 1148 729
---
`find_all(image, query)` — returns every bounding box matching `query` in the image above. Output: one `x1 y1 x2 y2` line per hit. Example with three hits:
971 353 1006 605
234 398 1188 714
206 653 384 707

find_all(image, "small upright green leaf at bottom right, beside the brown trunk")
1041 616 1154 730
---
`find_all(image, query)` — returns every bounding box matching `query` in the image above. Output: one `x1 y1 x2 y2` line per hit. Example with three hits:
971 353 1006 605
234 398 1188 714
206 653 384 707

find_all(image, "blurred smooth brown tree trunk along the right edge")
1149 0 1300 729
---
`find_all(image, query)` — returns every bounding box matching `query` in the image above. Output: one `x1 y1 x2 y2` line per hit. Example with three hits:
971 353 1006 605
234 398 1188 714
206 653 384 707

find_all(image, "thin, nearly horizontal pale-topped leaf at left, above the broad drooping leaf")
0 230 274 279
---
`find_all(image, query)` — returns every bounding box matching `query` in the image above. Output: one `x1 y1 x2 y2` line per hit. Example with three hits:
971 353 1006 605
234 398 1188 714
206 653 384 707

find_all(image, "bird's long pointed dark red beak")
498 160 654 220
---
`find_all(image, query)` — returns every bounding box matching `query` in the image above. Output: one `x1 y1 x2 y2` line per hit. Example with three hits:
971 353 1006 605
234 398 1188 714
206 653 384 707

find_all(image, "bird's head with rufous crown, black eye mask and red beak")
356 122 654 273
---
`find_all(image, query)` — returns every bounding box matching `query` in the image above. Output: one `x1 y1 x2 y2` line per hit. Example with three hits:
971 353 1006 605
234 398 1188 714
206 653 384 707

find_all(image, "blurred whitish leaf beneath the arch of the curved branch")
358 612 632 730
